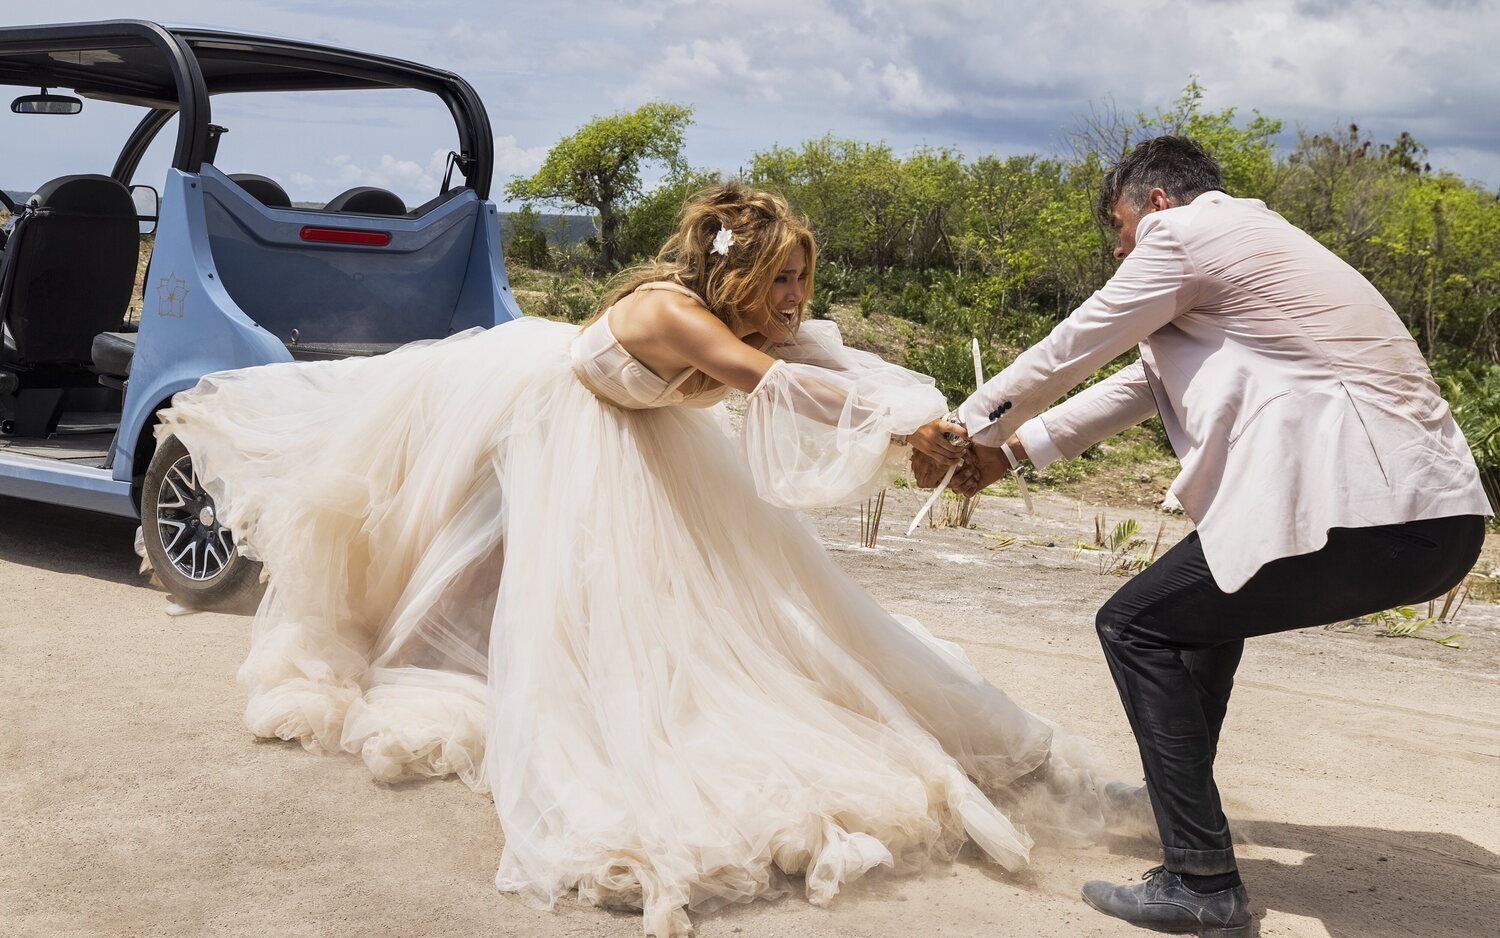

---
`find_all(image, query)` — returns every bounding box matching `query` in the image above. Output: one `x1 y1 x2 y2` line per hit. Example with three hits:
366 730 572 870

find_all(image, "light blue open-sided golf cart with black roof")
0 21 522 608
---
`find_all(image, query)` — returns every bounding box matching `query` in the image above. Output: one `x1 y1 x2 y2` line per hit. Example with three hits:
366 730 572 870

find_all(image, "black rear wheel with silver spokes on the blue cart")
141 437 264 612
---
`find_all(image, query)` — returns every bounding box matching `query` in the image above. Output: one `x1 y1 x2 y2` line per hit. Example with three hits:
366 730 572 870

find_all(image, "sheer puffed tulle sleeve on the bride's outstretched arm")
743 321 948 509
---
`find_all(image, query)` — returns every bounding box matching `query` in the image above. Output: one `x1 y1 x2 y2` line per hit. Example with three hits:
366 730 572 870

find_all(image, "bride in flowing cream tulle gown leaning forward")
159 183 1098 936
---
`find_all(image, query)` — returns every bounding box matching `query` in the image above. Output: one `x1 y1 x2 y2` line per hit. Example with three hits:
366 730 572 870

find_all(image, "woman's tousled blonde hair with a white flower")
596 182 816 341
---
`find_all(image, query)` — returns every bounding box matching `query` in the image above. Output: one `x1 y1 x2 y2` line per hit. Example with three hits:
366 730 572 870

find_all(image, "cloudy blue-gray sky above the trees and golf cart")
0 0 1500 204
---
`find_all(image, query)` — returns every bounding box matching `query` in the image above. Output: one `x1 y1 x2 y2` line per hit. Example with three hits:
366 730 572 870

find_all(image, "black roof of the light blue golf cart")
0 20 494 198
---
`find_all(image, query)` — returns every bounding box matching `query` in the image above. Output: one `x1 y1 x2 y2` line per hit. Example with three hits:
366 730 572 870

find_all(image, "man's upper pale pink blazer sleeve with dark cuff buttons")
959 212 1199 452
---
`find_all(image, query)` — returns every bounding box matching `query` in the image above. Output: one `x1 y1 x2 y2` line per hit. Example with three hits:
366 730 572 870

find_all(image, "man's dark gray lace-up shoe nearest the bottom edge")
1083 866 1251 938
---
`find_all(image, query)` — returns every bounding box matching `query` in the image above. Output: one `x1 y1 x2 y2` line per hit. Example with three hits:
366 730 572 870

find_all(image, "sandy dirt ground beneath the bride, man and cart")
0 491 1500 938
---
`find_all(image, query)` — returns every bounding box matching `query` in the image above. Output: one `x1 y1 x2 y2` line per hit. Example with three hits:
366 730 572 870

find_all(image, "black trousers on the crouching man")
1098 515 1485 875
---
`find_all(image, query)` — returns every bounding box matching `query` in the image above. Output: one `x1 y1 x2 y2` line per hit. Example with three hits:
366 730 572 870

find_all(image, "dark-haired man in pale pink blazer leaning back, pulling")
936 137 1491 935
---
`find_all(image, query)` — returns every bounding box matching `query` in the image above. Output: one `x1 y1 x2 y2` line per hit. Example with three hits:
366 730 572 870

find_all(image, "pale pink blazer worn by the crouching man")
960 192 1491 593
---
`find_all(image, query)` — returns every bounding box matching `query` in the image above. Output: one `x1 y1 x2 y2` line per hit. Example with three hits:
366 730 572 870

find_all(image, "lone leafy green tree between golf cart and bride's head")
506 102 693 269
